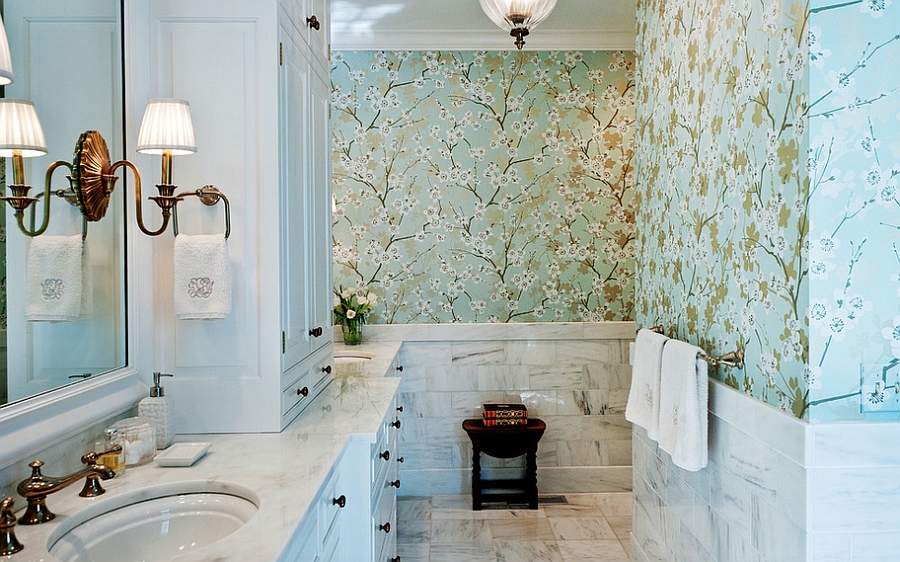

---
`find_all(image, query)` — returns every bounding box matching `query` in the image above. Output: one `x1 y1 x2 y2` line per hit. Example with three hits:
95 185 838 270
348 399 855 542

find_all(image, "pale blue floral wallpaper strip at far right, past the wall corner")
805 0 900 421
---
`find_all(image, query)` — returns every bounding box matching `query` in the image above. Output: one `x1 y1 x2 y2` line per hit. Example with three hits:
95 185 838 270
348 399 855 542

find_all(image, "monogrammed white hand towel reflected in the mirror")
25 234 84 322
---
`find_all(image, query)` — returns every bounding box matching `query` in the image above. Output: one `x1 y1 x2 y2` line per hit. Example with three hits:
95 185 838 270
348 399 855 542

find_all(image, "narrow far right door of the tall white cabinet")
309 70 334 349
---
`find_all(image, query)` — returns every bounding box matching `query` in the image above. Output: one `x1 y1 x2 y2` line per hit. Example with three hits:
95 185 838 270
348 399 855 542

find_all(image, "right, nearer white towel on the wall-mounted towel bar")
659 340 709 471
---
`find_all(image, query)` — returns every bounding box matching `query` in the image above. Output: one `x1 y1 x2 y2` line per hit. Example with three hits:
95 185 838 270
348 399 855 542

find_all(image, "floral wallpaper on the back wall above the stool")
332 51 636 323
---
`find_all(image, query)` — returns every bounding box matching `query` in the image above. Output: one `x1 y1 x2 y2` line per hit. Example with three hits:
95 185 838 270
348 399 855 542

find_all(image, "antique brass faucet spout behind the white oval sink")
16 453 116 525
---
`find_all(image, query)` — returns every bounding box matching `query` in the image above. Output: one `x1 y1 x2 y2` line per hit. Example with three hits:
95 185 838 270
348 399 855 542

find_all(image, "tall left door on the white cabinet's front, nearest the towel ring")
278 22 314 370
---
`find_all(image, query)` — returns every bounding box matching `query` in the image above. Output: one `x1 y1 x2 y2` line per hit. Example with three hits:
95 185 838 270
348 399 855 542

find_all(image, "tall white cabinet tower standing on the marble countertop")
125 0 333 433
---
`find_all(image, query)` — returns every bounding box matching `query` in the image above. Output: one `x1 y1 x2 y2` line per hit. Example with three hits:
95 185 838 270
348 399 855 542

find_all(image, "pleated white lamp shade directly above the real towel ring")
137 98 197 156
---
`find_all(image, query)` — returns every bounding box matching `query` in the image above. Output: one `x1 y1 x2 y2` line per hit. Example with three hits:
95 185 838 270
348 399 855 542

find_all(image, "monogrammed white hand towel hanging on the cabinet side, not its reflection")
173 234 231 320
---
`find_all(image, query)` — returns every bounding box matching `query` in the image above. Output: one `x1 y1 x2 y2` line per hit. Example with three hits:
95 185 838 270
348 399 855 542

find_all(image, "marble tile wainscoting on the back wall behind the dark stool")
356 322 635 496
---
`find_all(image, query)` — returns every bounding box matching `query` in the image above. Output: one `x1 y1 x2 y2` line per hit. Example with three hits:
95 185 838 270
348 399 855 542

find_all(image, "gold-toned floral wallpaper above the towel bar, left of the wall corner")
635 0 810 417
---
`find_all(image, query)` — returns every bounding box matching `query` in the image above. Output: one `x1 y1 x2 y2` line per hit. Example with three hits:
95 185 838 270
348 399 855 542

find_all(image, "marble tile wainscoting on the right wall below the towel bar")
631 380 900 562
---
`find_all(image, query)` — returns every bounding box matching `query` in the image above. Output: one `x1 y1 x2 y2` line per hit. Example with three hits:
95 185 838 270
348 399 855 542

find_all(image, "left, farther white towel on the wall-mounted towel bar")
625 330 669 439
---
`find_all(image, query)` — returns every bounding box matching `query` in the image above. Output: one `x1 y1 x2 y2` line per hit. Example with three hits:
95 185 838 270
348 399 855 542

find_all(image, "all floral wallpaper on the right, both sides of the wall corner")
635 0 900 422
